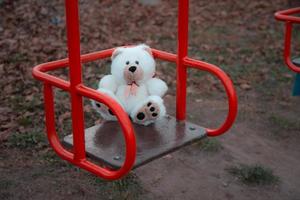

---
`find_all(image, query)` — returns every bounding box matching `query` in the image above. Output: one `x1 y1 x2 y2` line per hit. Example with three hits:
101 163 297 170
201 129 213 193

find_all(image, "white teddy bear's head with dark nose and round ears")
111 44 155 85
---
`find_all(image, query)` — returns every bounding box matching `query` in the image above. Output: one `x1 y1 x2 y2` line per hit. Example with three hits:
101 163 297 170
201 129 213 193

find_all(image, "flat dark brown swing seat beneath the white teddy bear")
64 116 206 169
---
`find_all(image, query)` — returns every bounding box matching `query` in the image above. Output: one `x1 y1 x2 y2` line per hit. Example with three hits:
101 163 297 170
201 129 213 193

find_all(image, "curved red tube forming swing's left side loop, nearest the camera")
44 83 136 180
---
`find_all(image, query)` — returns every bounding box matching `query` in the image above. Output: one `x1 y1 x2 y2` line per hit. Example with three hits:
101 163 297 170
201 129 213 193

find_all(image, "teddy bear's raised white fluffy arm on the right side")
147 78 168 97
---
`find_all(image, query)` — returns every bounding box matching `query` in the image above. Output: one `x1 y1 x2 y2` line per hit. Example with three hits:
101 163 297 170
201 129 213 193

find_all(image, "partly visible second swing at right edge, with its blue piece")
275 7 300 96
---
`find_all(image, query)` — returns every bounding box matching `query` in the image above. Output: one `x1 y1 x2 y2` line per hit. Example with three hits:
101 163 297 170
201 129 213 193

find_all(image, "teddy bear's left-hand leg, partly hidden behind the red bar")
92 88 122 121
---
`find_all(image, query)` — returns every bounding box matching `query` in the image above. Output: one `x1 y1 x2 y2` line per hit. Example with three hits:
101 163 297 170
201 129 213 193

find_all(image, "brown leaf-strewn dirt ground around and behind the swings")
0 0 300 200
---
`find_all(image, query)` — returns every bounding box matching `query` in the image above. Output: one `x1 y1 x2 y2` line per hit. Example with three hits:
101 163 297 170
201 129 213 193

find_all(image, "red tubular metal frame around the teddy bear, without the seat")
33 0 237 180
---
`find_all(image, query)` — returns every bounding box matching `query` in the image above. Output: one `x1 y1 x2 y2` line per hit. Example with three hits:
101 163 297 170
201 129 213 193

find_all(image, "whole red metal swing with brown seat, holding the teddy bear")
32 0 237 180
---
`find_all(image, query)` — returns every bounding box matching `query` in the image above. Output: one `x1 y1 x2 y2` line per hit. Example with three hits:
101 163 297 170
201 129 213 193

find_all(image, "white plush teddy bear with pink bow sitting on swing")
92 44 168 125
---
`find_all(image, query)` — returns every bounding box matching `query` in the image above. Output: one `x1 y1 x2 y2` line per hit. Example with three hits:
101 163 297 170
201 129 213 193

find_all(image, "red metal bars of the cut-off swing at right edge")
275 7 300 73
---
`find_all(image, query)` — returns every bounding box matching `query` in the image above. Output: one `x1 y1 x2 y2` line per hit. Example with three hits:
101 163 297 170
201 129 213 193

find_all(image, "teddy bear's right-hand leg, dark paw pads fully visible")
130 96 166 126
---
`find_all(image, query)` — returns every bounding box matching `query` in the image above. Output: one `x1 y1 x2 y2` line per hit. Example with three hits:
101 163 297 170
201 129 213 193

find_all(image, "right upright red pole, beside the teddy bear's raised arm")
176 0 189 120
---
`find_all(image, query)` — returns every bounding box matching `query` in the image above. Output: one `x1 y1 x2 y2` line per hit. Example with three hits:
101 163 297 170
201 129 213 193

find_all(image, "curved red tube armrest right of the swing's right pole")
184 58 238 136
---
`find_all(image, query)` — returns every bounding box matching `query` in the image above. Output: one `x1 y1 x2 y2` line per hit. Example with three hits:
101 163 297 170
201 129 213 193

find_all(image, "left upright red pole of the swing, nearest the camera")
65 0 86 162
